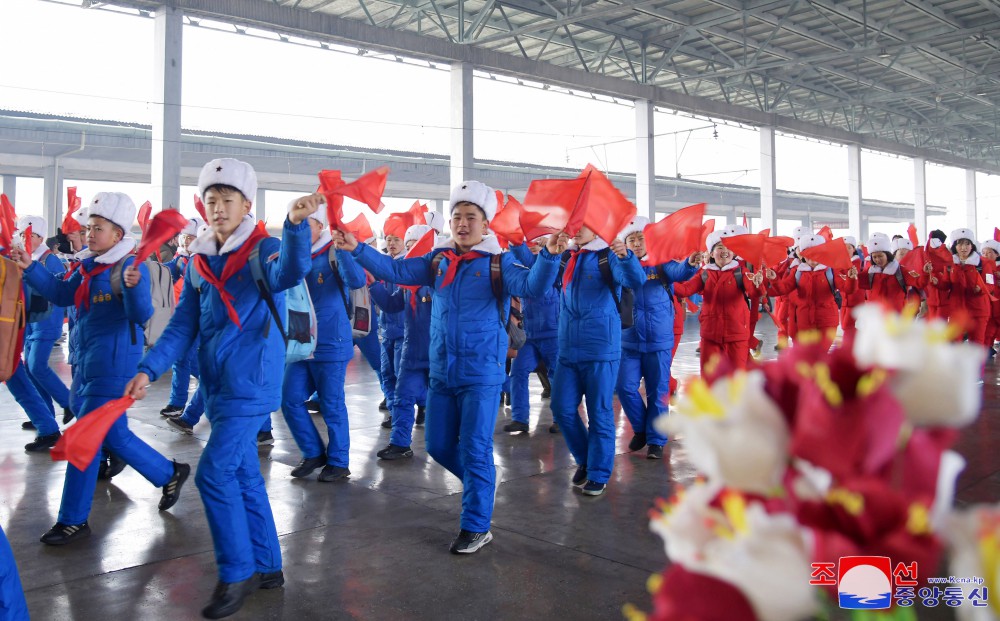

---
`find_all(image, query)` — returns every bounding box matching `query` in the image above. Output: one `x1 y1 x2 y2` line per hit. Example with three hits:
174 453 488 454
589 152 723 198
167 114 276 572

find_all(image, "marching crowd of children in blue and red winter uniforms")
0 159 1000 618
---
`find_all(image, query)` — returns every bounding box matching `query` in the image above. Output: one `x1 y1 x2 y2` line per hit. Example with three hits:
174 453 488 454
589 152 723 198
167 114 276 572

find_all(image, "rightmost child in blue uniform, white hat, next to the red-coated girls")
618 216 701 459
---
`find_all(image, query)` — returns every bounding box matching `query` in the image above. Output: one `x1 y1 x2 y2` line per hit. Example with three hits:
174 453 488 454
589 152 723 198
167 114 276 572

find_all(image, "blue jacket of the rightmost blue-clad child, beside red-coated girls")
622 261 698 354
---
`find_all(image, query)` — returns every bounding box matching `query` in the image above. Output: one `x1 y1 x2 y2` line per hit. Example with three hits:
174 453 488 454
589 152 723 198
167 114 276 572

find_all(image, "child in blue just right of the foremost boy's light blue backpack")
281 199 365 482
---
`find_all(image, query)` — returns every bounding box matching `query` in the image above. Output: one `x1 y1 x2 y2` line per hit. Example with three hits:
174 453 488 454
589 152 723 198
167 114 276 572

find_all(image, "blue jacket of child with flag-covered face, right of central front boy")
559 250 644 362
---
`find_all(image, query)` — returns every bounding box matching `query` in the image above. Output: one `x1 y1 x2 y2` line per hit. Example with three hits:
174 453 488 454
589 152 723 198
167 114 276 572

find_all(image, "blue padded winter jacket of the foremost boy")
139 219 311 417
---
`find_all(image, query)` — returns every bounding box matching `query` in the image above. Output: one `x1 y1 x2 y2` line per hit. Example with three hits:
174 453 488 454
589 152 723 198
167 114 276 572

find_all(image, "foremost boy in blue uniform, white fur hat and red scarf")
126 158 312 619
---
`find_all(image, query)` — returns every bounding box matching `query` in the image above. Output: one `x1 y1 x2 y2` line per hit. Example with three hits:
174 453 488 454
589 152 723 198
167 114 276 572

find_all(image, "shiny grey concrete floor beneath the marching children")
0 318 1000 621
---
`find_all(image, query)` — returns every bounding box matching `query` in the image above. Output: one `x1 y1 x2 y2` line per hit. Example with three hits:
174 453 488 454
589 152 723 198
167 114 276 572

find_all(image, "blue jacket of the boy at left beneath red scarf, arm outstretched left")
24 256 153 398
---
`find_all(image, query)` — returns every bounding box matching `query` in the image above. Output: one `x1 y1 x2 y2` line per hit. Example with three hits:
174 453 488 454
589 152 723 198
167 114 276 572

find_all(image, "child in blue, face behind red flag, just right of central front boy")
552 226 645 496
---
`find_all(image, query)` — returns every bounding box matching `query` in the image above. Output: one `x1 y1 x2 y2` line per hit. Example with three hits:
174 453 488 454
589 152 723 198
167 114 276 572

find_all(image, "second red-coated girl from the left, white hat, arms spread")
766 235 858 349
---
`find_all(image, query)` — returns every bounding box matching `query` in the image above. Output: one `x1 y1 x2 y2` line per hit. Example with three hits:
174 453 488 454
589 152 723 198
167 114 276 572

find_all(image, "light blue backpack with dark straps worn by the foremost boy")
188 240 319 364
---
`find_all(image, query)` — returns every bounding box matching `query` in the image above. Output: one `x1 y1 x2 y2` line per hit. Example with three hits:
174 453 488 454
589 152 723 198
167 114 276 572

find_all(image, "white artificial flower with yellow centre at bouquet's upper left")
656 371 789 494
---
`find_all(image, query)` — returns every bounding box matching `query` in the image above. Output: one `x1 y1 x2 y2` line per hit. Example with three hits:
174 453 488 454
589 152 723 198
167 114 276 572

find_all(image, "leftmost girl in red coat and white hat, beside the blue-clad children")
674 231 764 375
